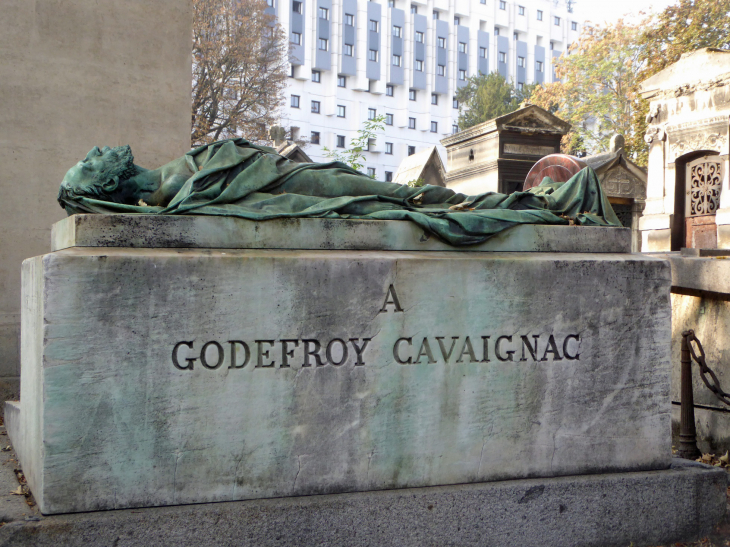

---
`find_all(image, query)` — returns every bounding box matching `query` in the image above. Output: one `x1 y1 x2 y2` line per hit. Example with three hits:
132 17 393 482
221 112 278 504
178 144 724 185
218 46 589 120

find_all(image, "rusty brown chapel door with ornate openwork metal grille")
684 156 723 249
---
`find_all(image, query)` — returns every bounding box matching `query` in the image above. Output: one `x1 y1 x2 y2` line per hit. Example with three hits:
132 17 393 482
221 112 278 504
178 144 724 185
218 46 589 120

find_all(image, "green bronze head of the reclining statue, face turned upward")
58 145 137 207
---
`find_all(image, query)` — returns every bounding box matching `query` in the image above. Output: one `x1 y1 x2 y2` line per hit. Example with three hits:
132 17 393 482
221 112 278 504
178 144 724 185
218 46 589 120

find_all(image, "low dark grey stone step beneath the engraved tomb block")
0 460 727 547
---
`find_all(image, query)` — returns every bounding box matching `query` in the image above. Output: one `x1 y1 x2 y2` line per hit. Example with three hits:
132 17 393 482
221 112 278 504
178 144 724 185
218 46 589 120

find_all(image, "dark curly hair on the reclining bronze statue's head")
57 145 137 208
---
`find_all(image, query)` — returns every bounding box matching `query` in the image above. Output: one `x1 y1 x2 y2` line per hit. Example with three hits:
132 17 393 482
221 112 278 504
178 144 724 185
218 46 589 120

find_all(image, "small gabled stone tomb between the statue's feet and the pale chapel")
583 135 646 252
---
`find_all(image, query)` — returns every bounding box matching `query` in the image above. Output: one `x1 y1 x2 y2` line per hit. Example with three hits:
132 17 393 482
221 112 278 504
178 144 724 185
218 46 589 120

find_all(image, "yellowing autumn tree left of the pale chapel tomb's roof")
530 21 645 163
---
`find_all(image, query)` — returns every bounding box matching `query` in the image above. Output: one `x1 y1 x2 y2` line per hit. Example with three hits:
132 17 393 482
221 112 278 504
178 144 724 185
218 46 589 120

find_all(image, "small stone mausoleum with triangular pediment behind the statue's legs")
441 105 570 195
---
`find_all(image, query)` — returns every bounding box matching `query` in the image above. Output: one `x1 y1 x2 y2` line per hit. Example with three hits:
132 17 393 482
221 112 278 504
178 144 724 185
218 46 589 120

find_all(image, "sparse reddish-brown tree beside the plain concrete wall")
191 0 289 146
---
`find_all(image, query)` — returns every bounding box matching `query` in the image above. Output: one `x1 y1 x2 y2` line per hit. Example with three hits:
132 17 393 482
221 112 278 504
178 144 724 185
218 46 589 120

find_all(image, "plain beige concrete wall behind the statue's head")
0 0 192 398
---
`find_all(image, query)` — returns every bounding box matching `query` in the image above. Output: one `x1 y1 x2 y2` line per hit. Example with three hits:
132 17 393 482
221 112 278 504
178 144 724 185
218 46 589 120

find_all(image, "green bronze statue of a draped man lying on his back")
58 139 621 245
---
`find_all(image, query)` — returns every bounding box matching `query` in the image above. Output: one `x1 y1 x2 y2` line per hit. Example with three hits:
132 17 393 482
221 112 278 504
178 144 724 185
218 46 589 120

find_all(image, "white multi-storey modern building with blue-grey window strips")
268 0 582 180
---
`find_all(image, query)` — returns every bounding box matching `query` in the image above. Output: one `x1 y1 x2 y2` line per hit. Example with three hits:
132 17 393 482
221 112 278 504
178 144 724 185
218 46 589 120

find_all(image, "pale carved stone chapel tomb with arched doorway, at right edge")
640 48 730 251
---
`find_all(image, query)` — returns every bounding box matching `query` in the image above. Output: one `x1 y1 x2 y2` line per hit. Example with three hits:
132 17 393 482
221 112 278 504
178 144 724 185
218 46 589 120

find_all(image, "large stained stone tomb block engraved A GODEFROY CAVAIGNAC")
7 217 671 514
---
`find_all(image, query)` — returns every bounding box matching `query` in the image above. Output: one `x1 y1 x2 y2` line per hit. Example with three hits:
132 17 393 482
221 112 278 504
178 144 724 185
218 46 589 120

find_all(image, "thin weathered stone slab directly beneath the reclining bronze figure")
51 215 631 253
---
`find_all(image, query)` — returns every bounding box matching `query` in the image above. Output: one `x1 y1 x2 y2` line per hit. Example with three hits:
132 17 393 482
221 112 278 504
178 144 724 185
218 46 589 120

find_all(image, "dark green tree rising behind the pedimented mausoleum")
456 72 536 130
